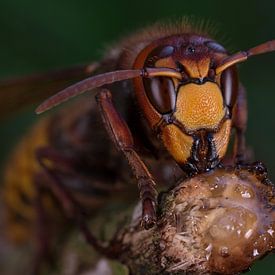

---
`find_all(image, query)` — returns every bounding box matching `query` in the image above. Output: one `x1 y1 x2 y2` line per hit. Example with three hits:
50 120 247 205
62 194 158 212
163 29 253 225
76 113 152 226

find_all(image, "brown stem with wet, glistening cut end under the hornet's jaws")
110 168 275 274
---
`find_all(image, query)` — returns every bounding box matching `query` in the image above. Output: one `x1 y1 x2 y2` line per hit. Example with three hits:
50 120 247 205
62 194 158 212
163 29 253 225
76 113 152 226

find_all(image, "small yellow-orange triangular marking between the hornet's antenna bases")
180 58 210 78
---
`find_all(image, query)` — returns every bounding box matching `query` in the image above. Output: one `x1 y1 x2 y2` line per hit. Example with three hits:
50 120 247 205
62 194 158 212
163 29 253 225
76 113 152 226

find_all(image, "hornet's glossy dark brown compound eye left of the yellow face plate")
143 77 176 114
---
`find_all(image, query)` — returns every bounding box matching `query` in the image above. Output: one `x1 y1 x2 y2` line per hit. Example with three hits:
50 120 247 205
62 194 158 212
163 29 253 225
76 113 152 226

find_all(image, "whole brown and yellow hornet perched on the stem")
0 22 275 272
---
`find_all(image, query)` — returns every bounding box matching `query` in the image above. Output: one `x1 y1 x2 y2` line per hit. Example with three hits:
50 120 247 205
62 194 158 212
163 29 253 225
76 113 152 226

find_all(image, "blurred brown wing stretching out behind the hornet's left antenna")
0 63 99 118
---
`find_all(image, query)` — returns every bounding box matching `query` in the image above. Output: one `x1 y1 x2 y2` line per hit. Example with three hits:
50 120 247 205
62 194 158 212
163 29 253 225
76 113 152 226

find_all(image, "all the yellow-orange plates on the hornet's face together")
156 57 231 164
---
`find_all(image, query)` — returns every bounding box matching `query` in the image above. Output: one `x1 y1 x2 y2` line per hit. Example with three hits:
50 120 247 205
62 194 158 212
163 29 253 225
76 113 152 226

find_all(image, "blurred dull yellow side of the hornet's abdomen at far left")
3 120 49 242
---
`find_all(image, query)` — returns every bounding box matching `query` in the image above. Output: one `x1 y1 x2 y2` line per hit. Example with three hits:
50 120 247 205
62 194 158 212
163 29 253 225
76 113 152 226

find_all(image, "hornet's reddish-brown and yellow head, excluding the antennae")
135 37 234 171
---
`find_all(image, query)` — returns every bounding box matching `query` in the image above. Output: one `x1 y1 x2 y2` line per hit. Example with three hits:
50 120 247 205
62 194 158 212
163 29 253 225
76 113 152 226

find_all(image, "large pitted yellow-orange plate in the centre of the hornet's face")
175 82 225 131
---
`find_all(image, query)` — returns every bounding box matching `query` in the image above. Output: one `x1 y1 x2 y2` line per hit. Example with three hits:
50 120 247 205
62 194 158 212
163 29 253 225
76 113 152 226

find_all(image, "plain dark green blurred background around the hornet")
0 0 275 275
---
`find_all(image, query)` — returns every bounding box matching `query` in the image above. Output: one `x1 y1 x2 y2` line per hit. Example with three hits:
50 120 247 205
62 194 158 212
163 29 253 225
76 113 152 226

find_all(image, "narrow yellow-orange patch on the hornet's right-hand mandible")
214 119 231 158
